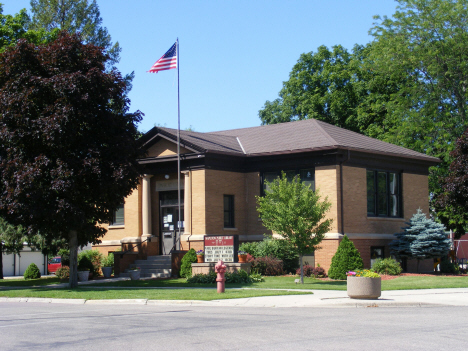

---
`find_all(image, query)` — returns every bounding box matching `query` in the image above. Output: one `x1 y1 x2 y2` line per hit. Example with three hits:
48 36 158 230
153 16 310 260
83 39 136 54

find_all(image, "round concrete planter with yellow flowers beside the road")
346 269 382 300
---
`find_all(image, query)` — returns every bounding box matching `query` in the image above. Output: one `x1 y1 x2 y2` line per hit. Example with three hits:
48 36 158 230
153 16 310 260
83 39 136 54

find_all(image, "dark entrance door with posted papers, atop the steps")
159 191 184 255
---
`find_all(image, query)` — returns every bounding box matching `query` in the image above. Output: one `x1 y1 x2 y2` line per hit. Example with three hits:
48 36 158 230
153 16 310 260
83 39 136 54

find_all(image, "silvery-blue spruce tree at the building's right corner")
390 209 450 272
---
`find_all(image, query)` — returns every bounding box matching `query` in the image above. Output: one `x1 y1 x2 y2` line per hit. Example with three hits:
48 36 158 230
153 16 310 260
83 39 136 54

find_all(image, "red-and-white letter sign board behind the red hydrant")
205 235 239 262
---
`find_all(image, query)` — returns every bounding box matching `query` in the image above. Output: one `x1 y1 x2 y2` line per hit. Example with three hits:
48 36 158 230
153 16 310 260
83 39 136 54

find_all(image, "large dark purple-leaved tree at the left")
0 32 141 287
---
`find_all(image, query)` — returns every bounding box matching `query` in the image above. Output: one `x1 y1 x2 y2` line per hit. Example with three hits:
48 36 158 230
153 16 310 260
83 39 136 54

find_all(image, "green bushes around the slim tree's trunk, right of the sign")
239 237 299 273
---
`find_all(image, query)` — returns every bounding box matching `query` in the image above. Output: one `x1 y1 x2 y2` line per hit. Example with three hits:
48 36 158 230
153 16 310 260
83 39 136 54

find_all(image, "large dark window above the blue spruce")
367 170 402 217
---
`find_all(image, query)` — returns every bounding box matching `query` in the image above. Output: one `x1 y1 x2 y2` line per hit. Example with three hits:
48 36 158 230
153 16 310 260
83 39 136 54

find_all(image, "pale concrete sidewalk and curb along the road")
0 278 468 308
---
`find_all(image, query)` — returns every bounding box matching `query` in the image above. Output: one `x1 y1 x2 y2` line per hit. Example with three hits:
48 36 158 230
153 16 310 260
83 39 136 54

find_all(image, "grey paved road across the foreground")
0 302 468 351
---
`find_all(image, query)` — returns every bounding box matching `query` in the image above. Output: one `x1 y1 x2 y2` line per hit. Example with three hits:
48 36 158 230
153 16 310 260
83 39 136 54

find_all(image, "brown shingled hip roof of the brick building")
148 119 439 162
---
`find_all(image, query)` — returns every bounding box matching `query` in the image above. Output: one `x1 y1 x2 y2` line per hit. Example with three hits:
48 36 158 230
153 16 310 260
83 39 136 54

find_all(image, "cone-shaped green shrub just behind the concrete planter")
328 235 364 279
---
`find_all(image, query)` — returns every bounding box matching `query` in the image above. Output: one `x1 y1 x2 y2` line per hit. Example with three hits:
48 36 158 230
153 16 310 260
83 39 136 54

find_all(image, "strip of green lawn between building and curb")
0 276 468 300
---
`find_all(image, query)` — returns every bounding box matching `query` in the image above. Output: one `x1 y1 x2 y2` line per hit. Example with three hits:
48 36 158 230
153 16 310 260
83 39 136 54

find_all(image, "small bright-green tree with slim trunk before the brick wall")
257 172 332 284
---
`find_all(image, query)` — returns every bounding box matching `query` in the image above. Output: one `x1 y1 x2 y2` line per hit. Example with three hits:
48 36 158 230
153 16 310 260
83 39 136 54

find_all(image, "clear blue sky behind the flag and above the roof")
0 0 397 132
